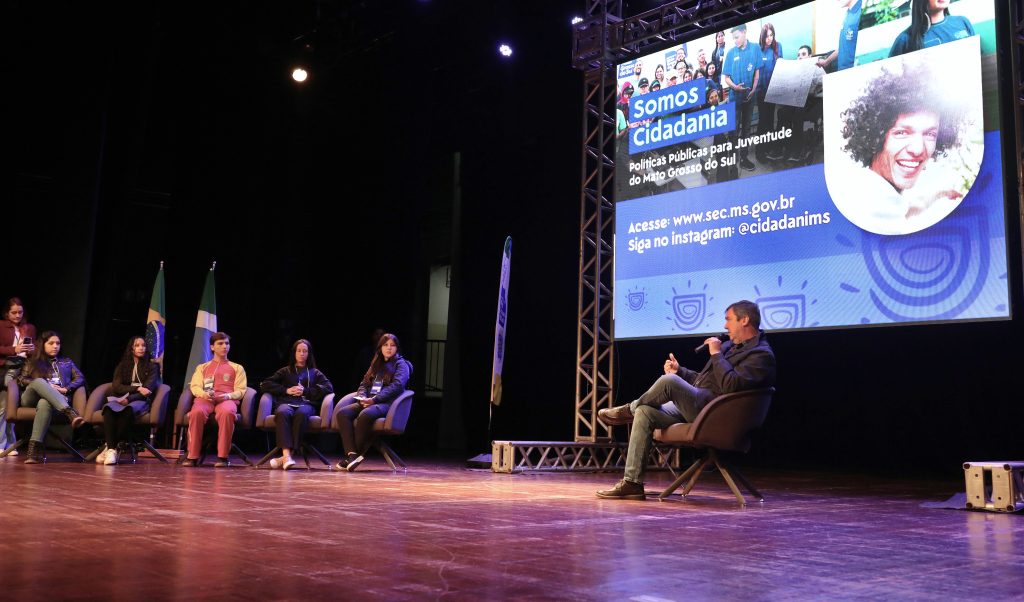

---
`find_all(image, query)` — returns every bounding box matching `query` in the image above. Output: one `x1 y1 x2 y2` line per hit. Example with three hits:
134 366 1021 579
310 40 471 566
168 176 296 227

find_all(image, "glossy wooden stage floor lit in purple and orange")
0 455 1024 601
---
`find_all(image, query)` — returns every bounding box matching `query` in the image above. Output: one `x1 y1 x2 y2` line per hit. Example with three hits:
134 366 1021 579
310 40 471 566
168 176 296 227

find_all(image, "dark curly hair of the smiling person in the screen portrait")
841 65 965 167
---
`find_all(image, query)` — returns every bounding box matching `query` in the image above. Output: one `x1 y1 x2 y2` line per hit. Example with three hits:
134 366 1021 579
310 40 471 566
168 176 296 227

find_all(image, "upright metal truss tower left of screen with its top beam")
572 0 804 444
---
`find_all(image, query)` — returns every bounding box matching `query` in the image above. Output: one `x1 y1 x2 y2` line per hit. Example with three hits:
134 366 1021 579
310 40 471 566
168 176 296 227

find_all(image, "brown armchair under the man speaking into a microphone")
654 388 775 506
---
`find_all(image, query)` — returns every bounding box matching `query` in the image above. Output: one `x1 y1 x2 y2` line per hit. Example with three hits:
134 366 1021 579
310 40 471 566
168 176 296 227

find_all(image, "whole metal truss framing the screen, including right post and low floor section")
494 0 1024 472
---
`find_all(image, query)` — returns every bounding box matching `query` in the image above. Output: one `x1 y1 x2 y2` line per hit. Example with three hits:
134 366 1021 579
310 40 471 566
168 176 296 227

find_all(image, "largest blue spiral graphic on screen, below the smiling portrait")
862 207 990 321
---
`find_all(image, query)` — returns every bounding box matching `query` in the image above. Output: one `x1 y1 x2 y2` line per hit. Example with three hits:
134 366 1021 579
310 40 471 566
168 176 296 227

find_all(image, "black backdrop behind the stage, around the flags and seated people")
9 0 1024 470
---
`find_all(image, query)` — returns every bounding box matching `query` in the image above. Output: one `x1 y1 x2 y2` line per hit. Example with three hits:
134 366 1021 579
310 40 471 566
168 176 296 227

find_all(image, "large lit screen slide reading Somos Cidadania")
614 0 1013 339
